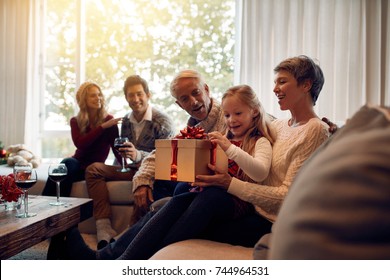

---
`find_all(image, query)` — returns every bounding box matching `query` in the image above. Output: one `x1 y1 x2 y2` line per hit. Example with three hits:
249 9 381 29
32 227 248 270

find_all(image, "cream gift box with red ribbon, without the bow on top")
155 139 228 182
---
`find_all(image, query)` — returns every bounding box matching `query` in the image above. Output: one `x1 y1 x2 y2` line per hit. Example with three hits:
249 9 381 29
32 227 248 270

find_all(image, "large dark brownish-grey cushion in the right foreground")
266 106 390 259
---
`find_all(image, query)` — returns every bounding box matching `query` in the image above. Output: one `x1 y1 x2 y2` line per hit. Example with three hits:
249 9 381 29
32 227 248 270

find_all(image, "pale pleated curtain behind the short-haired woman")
235 0 390 123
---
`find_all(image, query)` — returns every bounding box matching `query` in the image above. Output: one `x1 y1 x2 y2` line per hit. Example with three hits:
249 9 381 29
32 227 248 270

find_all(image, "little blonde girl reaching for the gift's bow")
175 85 274 215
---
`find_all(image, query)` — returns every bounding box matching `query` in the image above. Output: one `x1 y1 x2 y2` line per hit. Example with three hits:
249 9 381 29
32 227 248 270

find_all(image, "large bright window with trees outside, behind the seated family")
41 0 235 158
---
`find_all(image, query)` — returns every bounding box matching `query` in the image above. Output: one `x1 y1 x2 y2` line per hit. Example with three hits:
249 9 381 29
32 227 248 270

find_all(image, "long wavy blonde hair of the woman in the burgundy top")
76 82 108 134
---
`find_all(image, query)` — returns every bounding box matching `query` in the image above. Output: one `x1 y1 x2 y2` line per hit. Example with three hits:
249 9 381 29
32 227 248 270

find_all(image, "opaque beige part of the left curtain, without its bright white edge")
0 0 29 146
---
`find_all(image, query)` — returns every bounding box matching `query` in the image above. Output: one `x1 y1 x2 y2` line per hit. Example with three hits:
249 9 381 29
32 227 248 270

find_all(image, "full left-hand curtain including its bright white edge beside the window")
0 0 39 151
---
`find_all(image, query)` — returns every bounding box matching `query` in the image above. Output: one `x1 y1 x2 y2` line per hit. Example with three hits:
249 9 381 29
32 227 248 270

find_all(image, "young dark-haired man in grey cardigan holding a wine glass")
85 75 174 248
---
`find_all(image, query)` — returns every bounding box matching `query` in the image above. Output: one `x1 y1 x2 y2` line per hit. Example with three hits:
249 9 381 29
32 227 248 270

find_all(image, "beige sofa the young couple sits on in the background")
0 163 133 233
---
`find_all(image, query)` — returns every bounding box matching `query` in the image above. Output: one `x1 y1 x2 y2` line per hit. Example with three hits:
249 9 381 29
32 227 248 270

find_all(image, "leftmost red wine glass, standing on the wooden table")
14 164 37 218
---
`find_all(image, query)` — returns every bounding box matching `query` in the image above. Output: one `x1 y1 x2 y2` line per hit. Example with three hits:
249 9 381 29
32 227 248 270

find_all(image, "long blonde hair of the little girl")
222 85 276 182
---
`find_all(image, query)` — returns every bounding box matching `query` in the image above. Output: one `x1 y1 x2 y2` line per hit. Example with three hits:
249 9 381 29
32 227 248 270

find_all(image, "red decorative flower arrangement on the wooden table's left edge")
0 174 23 210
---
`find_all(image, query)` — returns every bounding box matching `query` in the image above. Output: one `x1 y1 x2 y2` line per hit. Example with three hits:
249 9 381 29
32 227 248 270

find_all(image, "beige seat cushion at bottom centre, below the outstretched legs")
150 239 253 260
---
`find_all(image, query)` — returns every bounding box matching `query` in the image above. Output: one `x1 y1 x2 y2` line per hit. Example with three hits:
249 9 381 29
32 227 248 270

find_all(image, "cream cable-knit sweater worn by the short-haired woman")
228 118 329 222
